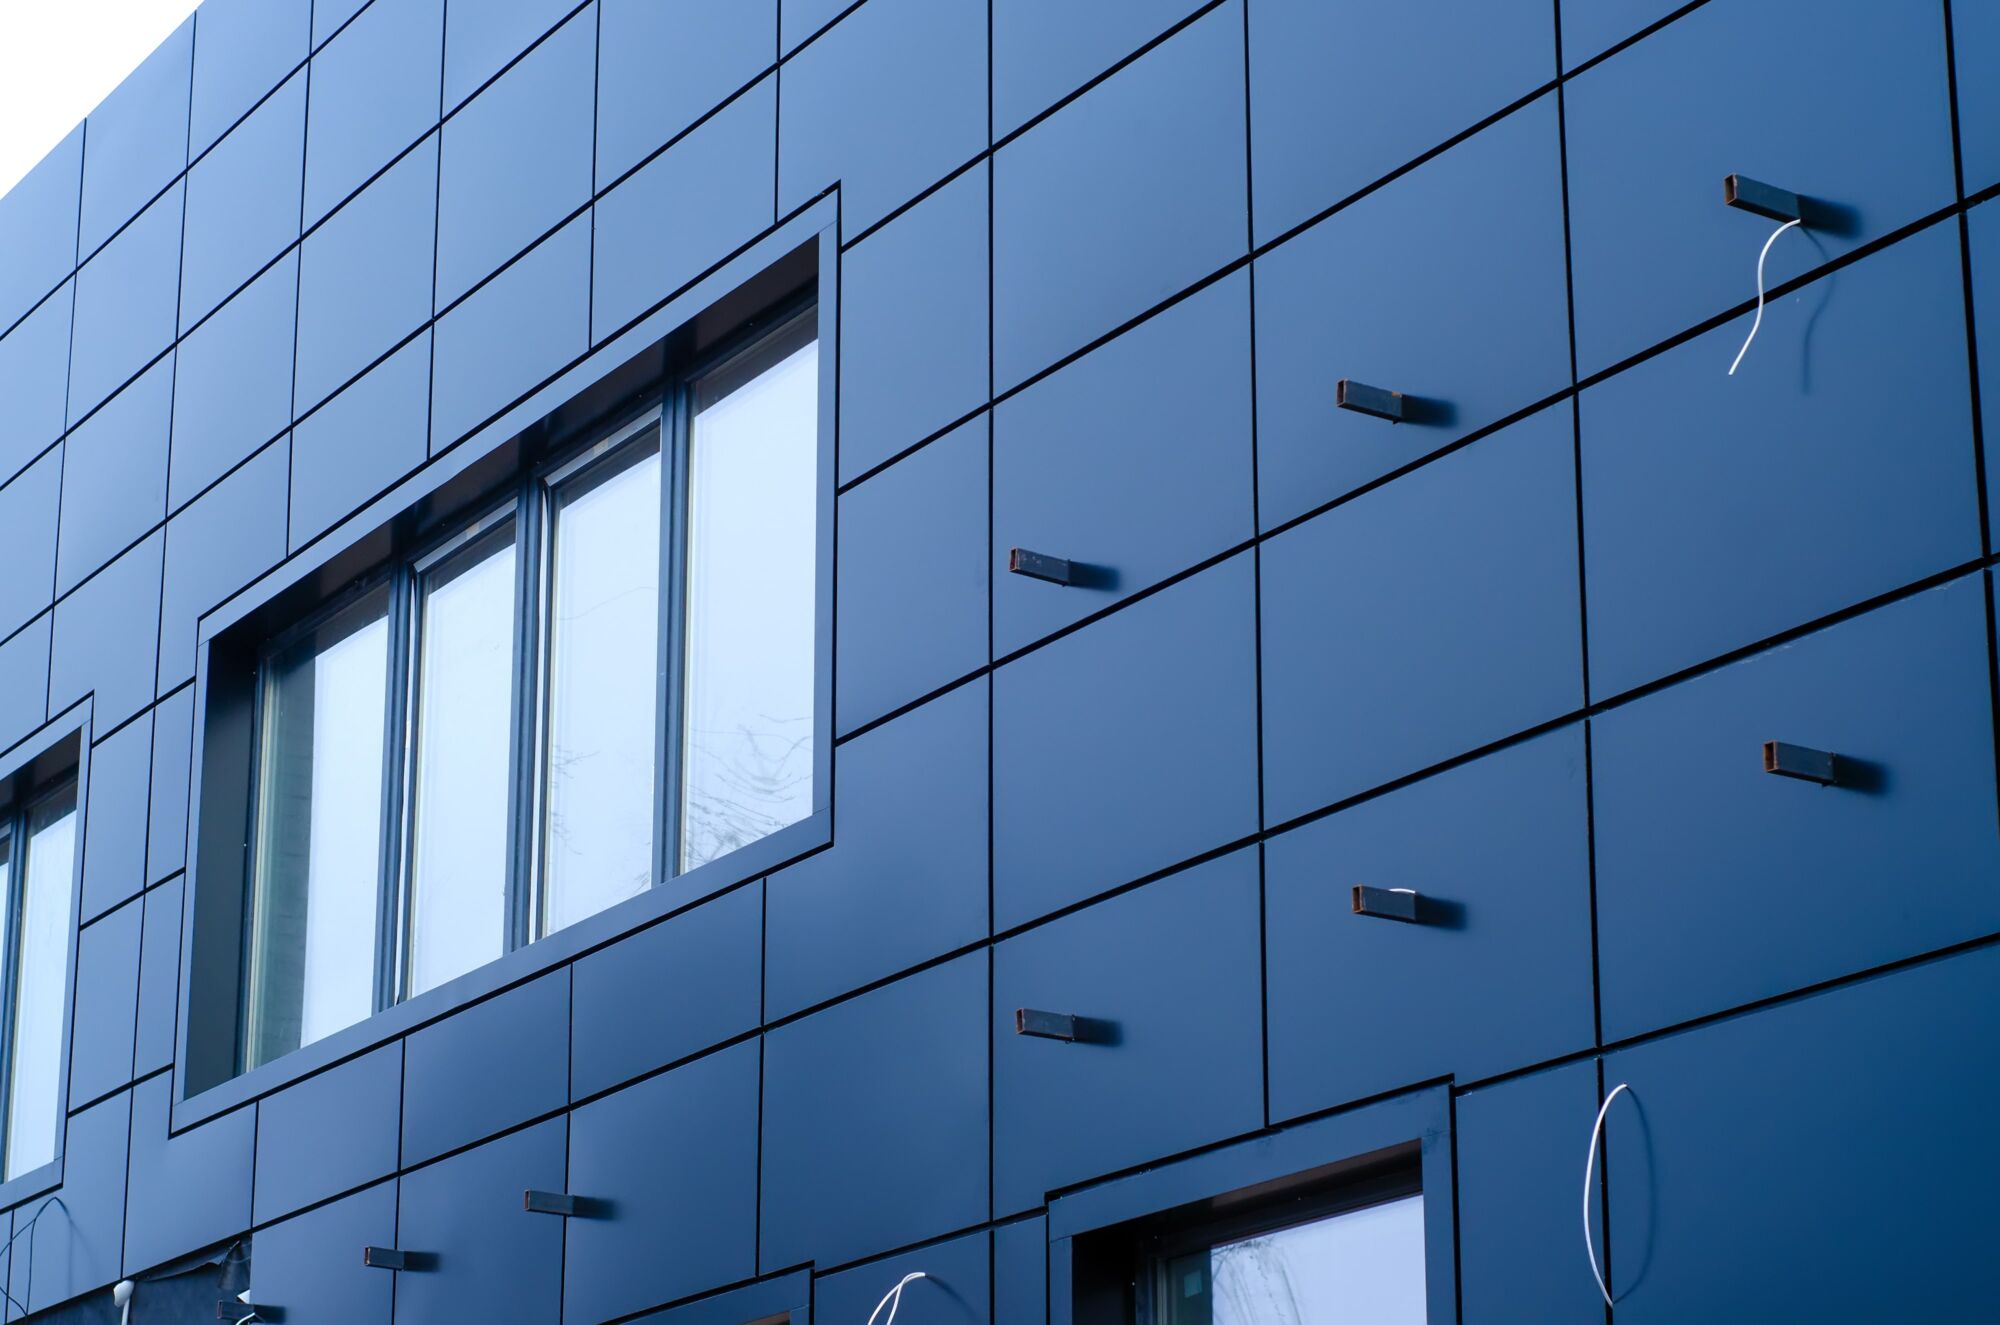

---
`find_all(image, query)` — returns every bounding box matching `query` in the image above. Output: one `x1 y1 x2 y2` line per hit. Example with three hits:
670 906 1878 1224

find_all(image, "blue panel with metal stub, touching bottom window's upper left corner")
992 849 1264 1215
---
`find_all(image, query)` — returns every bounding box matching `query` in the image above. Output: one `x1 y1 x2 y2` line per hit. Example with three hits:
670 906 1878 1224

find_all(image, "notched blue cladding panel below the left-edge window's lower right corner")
8 1079 130 1319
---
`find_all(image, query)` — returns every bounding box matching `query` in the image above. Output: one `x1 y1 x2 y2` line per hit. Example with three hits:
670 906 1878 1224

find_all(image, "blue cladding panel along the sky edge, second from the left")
78 18 194 258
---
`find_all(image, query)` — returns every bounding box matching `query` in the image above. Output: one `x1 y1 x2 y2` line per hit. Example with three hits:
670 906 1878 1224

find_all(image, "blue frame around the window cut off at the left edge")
0 699 92 1205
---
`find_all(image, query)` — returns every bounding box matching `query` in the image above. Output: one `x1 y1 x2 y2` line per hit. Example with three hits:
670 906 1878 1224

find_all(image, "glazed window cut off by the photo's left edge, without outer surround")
0 781 76 1179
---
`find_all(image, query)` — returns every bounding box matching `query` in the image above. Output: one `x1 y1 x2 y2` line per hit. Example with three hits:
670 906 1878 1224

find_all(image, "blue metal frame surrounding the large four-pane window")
184 198 840 1133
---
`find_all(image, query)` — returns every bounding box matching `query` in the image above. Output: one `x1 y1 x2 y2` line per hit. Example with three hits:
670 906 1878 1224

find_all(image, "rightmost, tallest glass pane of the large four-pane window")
680 316 820 871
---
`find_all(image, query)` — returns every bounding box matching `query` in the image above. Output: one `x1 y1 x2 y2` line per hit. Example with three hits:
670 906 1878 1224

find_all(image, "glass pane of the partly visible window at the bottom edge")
1160 1195 1426 1325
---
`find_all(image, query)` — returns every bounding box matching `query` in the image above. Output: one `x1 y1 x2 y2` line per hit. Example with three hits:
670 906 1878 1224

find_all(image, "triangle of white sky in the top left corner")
0 0 196 194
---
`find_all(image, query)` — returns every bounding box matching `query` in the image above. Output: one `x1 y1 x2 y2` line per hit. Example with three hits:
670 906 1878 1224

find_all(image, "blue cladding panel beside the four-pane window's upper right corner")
840 168 990 480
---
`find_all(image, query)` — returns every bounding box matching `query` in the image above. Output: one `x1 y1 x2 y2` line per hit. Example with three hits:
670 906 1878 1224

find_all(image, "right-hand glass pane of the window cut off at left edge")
6 787 76 1177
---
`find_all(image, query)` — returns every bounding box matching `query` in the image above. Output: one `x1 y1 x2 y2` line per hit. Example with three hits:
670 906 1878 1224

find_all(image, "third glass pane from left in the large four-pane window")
542 432 660 933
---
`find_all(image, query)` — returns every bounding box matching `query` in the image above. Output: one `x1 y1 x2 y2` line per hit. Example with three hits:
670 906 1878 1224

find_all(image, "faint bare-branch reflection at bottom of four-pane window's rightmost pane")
682 715 812 869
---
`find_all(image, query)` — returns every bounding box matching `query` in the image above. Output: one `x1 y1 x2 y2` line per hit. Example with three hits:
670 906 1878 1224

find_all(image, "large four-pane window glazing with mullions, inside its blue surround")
238 312 822 1069
